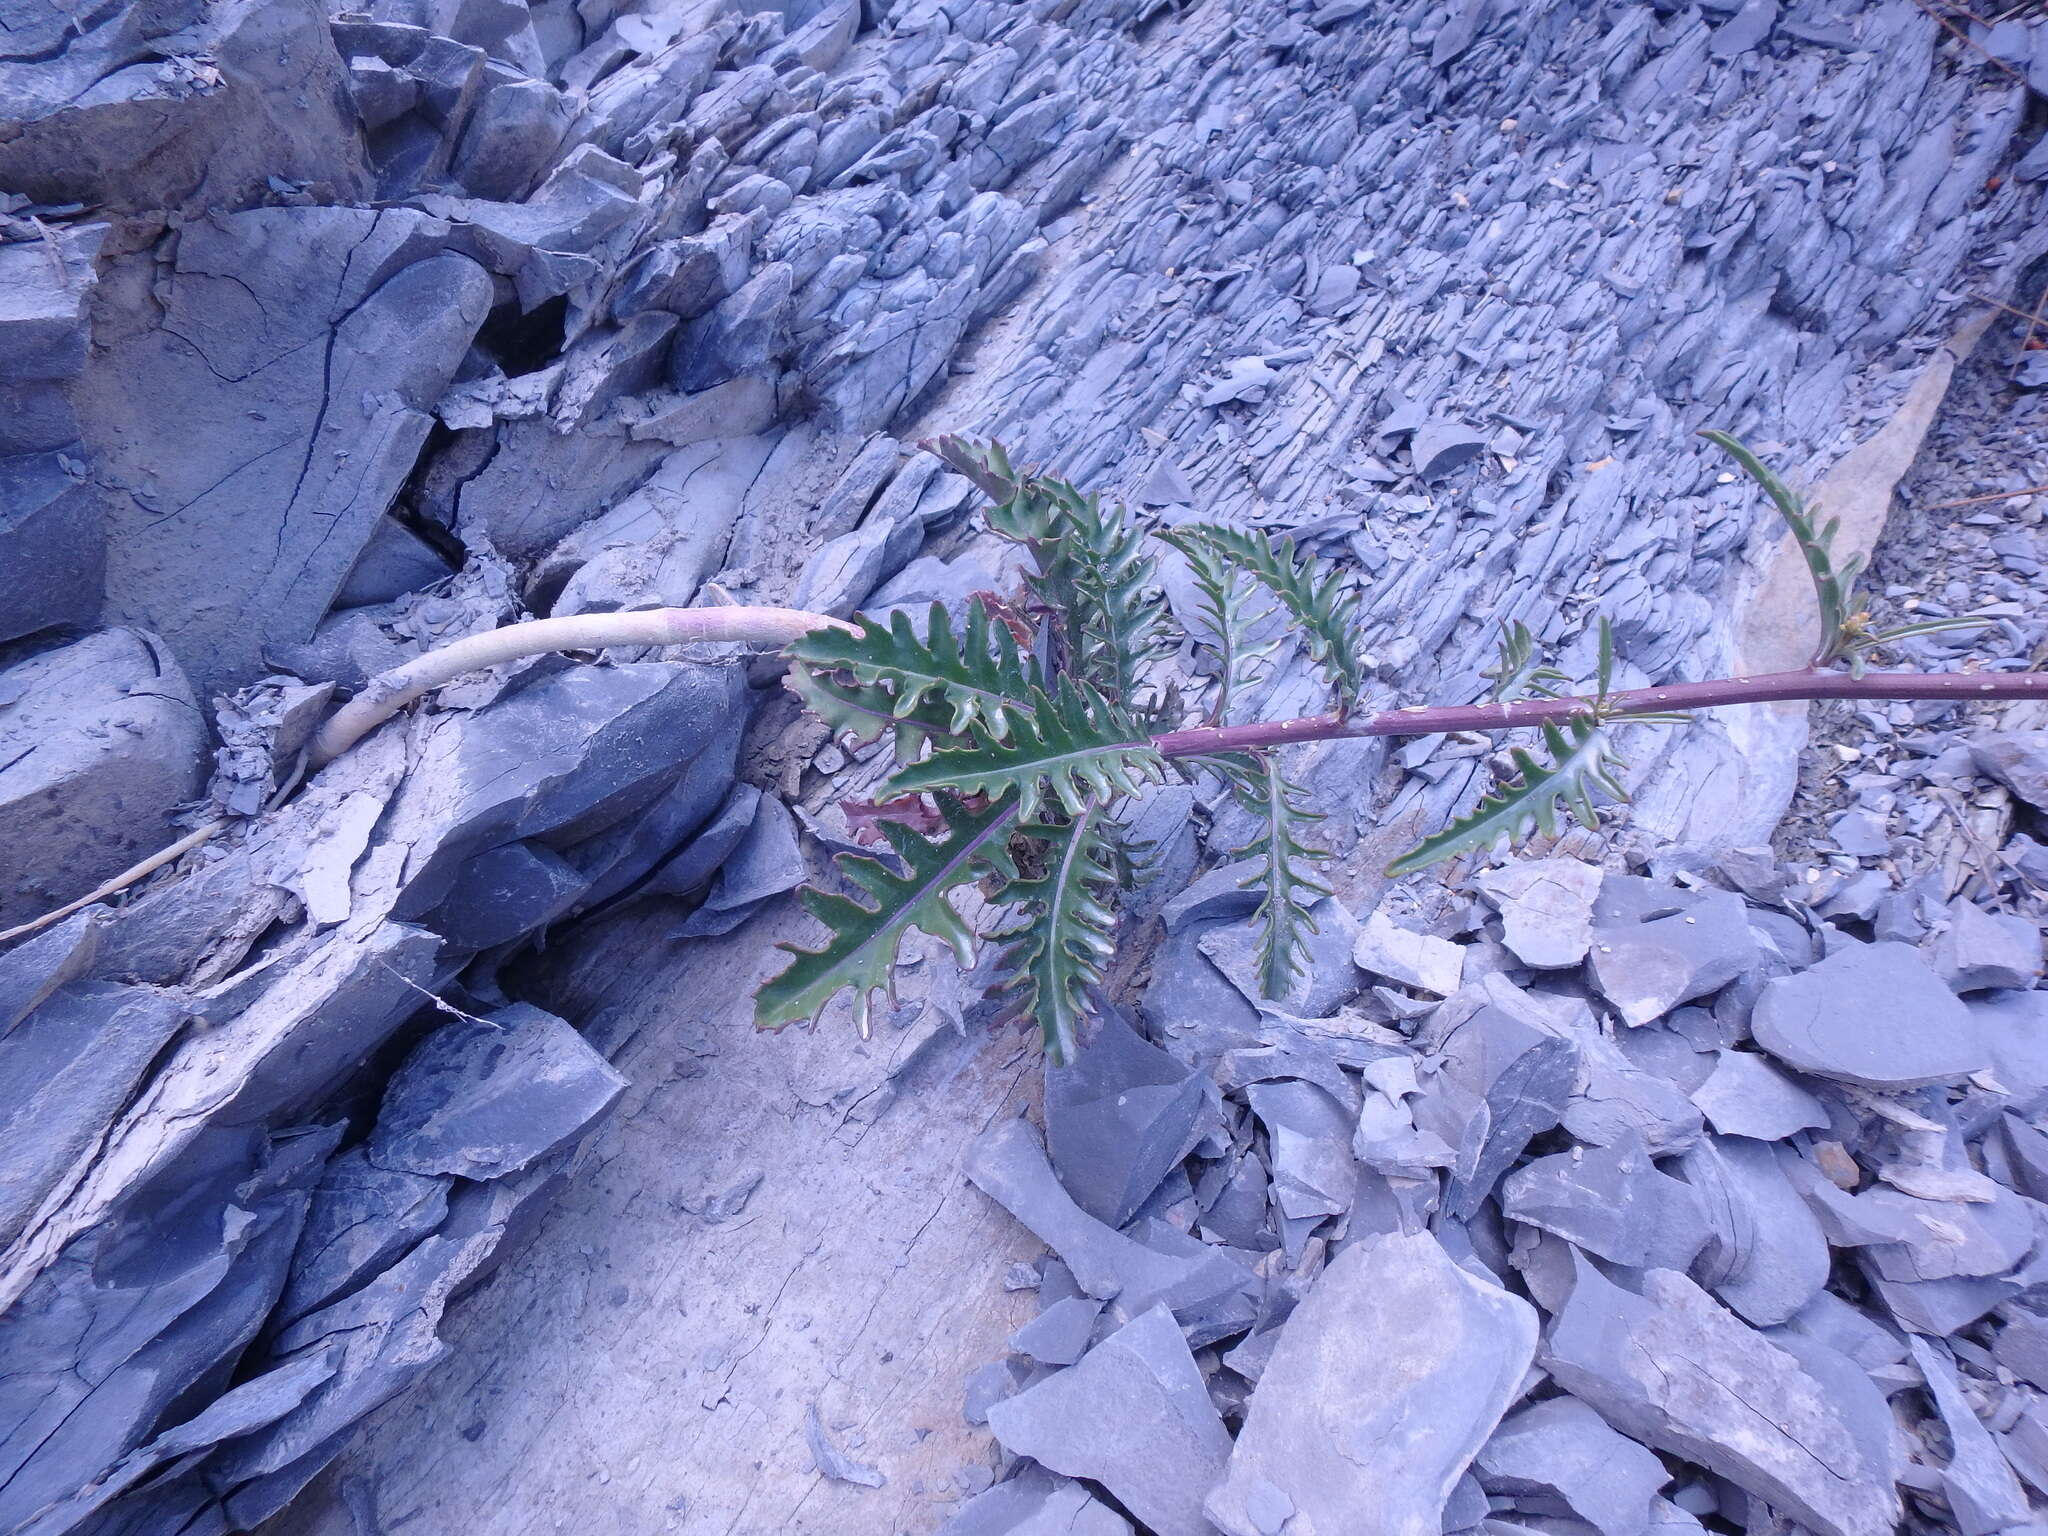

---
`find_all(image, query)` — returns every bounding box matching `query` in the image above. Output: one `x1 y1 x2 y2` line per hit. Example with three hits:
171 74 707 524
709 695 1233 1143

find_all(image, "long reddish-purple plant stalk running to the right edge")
1151 668 2048 758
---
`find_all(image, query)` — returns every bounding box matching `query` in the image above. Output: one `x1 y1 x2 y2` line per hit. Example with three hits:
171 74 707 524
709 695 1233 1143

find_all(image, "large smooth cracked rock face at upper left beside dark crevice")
92 207 492 694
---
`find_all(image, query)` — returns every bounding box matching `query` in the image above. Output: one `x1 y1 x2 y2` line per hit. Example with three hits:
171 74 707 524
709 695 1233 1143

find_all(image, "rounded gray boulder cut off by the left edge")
0 629 207 926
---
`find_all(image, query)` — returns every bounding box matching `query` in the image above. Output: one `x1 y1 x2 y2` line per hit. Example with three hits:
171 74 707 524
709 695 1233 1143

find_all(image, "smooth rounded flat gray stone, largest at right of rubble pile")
1749 942 1991 1087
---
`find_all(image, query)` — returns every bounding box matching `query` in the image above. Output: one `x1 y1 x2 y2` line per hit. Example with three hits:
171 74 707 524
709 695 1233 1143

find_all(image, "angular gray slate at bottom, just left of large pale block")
989 1307 1231 1536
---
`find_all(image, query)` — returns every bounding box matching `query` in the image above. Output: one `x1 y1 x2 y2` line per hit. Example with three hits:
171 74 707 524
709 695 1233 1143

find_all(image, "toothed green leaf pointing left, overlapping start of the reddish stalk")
881 678 1165 821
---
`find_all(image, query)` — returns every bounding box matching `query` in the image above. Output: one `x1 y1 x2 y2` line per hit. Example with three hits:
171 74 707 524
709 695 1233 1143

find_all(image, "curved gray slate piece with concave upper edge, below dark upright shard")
965 1120 1245 1315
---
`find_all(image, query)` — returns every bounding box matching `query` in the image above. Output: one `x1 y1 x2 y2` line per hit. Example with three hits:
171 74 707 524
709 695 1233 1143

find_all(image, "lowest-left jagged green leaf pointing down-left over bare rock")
754 797 1018 1036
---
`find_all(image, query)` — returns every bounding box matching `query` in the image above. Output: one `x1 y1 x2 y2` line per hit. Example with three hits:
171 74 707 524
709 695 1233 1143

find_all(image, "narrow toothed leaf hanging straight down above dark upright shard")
991 801 1120 1067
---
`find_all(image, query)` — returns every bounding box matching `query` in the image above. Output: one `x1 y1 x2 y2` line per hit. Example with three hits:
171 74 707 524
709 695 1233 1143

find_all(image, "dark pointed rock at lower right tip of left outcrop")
369 1004 627 1180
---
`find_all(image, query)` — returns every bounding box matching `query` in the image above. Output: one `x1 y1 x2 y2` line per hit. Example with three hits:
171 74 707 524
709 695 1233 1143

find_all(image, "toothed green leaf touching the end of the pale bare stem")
786 602 1036 739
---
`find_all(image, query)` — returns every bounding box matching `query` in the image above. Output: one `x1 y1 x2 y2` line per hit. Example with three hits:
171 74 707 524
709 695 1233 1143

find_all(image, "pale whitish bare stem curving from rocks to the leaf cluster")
307 606 854 770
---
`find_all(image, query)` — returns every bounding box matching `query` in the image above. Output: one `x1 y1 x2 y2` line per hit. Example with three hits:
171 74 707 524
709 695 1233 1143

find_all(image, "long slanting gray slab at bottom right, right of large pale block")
1538 1260 1898 1536
